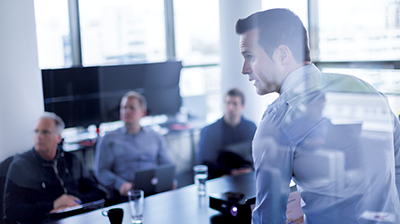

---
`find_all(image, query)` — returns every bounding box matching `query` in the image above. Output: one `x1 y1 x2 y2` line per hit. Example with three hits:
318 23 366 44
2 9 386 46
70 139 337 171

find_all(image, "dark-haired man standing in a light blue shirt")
236 9 400 224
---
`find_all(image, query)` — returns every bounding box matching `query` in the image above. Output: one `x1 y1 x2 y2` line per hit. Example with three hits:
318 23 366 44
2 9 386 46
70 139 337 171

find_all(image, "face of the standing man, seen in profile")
240 28 284 95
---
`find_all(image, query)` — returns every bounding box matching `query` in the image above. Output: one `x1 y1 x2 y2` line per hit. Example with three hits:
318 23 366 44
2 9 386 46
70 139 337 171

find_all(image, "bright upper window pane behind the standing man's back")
317 0 400 61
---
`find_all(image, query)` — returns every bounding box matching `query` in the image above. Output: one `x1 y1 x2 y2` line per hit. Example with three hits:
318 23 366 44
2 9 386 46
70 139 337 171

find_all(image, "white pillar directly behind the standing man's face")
219 0 268 124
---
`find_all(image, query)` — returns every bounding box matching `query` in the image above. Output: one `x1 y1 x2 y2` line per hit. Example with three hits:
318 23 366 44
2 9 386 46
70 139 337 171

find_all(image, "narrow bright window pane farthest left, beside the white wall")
34 0 72 69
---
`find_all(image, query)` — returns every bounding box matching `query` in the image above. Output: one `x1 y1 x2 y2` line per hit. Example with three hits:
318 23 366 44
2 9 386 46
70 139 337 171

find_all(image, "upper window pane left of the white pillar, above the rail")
174 0 220 65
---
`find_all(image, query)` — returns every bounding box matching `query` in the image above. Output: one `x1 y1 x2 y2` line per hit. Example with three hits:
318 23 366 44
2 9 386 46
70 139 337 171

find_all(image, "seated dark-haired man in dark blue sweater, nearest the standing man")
198 88 256 178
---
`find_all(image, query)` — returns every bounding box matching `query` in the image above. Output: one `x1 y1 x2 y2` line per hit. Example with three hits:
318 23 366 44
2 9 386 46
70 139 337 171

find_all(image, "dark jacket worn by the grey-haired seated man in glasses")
4 148 104 223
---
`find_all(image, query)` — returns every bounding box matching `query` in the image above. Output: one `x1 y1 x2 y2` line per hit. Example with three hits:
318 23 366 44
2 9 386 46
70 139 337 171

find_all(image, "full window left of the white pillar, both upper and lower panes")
174 0 222 123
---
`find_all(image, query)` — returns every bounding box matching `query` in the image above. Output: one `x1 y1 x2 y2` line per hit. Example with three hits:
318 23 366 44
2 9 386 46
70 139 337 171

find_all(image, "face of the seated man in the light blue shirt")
120 98 146 124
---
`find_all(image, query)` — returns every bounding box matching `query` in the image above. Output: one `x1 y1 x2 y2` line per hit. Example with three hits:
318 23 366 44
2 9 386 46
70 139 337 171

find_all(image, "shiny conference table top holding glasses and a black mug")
47 172 256 224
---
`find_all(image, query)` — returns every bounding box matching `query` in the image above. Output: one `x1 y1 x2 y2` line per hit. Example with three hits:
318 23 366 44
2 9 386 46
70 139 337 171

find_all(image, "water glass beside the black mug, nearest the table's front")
128 190 144 224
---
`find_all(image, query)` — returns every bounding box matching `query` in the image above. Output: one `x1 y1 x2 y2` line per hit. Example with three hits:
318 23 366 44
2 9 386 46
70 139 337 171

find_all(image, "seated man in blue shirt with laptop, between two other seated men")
96 91 172 200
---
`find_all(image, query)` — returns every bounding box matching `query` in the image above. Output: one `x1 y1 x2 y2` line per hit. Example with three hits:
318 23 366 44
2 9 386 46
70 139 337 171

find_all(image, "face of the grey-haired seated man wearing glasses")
33 118 61 155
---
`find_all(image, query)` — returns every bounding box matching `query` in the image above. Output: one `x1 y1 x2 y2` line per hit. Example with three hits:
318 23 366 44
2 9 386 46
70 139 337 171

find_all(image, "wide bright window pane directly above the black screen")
79 0 166 65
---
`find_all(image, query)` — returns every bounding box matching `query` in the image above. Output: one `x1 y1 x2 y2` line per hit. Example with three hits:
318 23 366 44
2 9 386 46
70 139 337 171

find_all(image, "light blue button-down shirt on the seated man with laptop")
96 126 172 190
